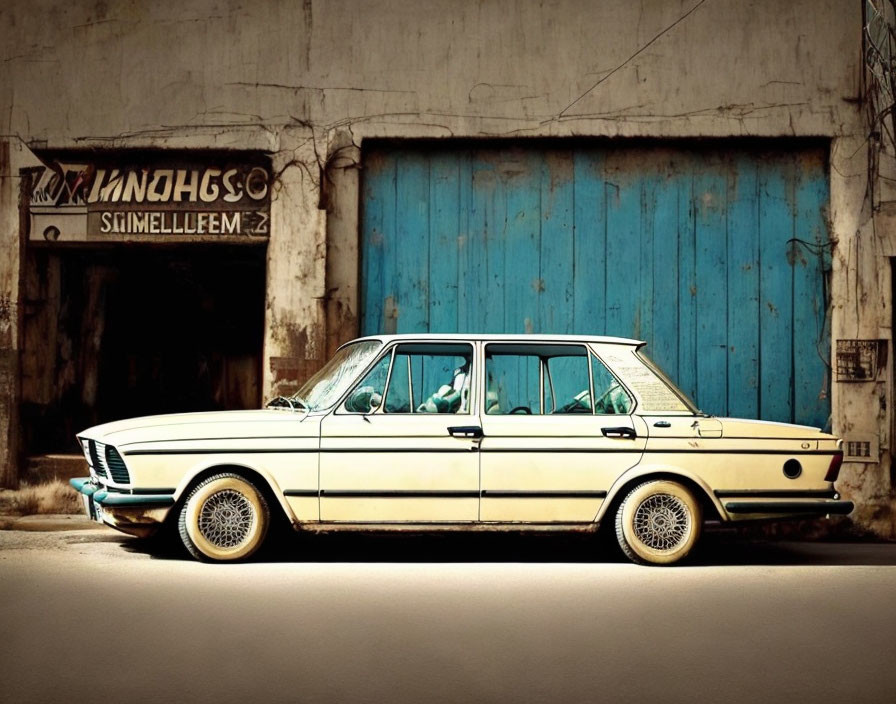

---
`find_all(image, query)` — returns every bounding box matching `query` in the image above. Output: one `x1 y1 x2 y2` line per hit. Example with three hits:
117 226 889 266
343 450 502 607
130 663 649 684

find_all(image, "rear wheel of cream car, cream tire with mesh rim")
616 479 703 565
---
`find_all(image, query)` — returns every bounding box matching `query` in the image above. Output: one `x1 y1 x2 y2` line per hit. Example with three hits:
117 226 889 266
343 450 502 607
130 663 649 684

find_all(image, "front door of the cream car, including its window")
320 343 480 523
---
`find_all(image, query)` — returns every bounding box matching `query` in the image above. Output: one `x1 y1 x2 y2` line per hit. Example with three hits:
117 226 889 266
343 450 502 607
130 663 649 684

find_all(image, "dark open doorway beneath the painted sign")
22 245 265 455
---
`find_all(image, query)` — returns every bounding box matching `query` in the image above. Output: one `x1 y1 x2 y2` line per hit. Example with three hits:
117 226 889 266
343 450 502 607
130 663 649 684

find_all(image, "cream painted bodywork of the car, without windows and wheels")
73 336 852 536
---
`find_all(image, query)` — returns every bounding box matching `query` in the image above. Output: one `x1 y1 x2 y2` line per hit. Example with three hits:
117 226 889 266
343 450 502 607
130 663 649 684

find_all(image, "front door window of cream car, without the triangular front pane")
384 344 473 413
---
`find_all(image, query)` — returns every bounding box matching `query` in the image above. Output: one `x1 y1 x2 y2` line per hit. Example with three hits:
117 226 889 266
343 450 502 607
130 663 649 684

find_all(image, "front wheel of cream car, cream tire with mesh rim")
178 472 271 562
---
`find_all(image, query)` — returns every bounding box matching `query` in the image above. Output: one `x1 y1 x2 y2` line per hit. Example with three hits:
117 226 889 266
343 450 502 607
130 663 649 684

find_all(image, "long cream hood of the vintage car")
78 409 317 445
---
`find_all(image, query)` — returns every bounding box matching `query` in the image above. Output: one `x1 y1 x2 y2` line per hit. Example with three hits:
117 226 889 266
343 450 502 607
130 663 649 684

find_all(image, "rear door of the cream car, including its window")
479 343 647 523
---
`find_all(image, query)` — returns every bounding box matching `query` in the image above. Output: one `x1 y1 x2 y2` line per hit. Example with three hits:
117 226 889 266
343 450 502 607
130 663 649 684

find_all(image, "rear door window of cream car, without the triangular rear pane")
485 344 592 415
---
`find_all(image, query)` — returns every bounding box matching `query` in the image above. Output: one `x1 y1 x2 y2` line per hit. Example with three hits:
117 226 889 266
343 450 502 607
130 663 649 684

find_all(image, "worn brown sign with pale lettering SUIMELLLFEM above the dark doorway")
29 158 271 242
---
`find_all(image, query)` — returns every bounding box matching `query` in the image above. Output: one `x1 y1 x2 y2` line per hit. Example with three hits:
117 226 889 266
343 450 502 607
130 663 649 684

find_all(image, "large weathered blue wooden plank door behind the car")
361 141 830 426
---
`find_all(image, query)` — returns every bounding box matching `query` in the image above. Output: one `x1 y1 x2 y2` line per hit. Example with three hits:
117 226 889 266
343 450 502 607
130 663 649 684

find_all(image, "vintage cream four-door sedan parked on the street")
72 334 853 564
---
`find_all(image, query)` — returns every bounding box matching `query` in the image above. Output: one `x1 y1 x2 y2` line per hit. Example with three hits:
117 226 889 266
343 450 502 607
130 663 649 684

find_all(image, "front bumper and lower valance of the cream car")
69 477 174 538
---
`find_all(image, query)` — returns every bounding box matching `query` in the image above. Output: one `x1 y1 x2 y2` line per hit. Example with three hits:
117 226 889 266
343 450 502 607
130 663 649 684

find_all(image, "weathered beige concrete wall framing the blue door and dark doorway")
0 0 896 533
